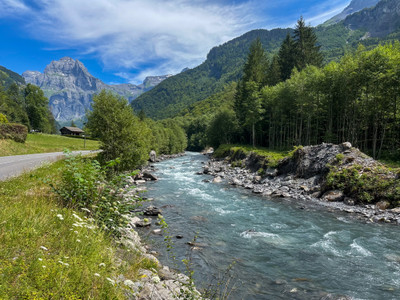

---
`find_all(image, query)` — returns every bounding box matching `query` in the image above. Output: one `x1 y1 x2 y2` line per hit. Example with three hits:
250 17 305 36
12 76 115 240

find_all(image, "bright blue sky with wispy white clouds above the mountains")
0 0 350 84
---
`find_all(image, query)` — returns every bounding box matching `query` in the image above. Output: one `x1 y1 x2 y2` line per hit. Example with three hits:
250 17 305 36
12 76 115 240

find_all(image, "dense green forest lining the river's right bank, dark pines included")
176 19 400 159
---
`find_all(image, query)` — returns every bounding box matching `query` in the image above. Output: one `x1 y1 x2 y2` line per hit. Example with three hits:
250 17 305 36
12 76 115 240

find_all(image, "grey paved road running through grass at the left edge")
0 151 93 181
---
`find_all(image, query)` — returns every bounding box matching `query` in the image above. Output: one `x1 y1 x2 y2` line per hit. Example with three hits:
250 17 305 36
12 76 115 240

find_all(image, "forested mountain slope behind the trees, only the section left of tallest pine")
132 28 292 119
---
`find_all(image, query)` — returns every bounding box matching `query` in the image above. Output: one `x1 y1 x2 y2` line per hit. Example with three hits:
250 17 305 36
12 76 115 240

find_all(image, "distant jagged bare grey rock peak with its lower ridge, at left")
22 57 171 121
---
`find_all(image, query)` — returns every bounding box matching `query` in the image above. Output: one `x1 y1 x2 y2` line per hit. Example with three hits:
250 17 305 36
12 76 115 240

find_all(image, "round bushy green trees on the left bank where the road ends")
85 90 187 172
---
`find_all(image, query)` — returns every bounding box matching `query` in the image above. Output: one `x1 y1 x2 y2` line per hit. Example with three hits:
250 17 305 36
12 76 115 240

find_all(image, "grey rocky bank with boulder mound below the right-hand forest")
203 143 400 225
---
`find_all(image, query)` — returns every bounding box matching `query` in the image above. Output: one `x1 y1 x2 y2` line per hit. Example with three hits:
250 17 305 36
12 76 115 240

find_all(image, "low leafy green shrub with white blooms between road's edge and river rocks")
50 153 141 236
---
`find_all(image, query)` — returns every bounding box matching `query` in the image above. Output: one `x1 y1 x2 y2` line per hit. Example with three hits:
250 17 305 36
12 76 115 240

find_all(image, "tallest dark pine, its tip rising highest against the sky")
293 17 323 71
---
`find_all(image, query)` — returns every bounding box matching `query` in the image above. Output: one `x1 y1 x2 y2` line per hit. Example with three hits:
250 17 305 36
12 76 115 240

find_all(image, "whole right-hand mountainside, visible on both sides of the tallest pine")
131 0 400 119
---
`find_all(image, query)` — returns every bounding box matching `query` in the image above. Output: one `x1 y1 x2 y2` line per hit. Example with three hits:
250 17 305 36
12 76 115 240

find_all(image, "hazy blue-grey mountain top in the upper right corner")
343 0 400 37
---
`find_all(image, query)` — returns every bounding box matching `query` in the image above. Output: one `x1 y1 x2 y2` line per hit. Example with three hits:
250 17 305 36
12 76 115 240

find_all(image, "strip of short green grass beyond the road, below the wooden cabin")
0 133 99 156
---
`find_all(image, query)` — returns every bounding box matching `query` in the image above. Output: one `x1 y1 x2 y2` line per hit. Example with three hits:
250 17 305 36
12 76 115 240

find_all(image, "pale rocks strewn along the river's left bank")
108 153 200 300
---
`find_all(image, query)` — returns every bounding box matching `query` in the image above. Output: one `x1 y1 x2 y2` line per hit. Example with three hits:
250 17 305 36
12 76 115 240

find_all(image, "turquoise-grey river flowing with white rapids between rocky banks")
138 152 400 300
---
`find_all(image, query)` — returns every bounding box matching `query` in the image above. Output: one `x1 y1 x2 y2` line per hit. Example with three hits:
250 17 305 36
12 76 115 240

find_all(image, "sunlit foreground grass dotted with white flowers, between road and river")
0 161 157 299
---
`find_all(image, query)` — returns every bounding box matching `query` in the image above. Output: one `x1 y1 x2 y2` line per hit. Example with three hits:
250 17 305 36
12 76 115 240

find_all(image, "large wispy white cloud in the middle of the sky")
21 0 251 81
